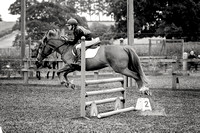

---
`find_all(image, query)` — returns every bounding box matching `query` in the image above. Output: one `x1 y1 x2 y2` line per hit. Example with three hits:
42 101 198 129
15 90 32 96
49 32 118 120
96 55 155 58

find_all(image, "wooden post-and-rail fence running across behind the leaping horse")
0 56 200 88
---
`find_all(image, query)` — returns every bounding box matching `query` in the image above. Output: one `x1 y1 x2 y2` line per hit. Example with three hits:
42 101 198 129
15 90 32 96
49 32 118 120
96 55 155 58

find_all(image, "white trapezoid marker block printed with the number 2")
135 98 152 111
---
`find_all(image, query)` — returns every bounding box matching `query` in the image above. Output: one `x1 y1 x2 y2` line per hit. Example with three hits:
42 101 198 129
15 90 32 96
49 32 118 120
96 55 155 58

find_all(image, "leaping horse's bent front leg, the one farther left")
57 65 75 87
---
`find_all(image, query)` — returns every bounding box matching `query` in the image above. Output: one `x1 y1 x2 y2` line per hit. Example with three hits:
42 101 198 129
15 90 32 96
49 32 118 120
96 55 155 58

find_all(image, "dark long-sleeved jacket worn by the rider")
72 26 92 44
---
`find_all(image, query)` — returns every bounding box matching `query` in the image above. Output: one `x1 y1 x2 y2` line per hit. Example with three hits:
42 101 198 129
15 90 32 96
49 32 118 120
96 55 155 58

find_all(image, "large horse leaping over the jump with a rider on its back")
36 30 151 95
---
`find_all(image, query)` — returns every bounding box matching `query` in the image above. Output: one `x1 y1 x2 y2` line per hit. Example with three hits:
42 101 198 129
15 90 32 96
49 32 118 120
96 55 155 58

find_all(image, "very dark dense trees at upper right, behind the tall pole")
107 0 200 40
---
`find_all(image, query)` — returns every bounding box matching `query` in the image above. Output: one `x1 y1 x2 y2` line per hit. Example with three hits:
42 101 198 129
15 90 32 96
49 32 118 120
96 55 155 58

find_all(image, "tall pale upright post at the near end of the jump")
80 36 86 117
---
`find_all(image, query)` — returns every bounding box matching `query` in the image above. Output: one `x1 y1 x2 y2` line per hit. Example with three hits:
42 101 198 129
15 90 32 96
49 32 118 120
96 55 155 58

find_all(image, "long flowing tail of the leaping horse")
124 47 148 84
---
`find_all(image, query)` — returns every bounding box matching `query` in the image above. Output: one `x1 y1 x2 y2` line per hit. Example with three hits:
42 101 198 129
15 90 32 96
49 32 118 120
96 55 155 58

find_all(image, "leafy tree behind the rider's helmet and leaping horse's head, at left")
9 0 87 40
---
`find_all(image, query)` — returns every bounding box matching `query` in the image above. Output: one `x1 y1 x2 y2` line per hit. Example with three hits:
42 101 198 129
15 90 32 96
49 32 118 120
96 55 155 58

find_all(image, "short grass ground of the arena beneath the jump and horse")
0 73 200 133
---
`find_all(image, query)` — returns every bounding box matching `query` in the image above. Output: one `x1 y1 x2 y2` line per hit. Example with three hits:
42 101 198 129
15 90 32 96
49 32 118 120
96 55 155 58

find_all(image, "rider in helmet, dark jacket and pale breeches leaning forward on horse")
66 18 93 65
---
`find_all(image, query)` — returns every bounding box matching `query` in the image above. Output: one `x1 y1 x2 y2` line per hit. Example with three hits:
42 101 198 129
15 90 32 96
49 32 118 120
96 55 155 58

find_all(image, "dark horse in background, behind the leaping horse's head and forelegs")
31 43 58 80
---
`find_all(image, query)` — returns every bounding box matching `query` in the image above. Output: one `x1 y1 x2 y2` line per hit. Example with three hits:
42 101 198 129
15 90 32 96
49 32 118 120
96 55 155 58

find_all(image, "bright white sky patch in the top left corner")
0 0 19 22
